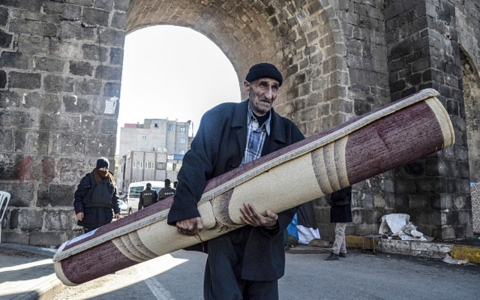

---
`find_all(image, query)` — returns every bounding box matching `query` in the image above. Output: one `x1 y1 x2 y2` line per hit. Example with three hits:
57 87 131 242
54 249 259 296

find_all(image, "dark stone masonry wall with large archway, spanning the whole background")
0 0 480 246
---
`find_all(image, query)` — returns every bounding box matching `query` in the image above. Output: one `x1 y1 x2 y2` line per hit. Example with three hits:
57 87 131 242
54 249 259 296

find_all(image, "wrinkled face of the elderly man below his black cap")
243 78 280 117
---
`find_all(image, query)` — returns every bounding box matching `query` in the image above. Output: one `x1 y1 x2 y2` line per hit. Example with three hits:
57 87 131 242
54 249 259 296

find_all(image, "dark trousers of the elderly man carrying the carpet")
203 230 278 300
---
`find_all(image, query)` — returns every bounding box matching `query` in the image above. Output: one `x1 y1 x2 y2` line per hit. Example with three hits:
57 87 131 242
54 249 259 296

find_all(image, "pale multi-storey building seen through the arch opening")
115 119 192 192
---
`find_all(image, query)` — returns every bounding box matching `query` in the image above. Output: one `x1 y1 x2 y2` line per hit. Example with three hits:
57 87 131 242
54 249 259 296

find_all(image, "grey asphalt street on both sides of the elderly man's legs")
51 250 480 300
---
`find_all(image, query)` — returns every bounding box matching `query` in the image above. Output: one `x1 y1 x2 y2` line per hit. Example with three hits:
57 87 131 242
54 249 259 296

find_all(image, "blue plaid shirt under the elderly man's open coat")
240 104 272 166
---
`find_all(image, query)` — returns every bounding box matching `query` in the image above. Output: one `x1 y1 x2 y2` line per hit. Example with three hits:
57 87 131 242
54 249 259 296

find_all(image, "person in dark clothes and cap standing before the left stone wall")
73 157 120 233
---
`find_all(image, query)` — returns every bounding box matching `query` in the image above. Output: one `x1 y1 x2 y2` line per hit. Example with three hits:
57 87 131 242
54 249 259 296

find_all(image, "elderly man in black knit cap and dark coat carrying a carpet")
168 63 304 300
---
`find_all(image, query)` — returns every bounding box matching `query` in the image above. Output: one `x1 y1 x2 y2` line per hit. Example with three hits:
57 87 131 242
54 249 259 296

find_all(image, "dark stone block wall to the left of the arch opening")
0 0 129 246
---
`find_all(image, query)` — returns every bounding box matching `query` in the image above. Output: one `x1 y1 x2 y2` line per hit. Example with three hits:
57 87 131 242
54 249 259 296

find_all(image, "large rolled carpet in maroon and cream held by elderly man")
54 89 454 285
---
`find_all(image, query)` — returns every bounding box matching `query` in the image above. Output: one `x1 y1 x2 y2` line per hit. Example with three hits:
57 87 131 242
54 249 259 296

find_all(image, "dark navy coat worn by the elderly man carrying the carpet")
168 100 304 281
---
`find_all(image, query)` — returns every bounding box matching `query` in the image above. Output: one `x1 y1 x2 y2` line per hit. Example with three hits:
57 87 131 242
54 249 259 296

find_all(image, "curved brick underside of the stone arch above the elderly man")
126 0 352 136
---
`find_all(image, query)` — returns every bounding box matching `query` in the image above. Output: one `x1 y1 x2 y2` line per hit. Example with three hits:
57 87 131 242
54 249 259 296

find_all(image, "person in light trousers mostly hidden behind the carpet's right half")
326 186 352 260
